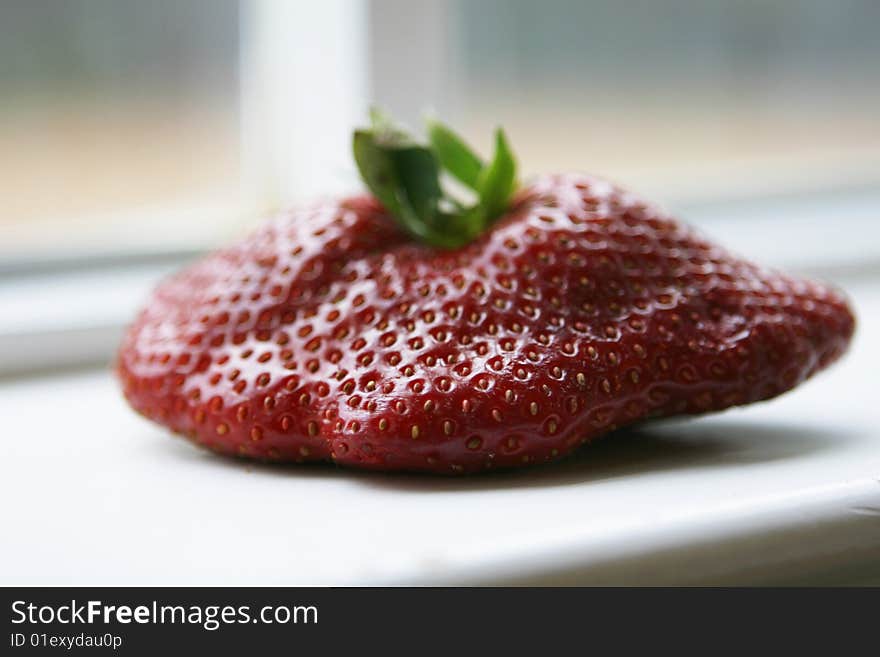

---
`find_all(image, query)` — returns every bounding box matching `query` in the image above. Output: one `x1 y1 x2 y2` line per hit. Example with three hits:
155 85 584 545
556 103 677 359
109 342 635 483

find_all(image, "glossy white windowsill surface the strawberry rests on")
0 282 880 585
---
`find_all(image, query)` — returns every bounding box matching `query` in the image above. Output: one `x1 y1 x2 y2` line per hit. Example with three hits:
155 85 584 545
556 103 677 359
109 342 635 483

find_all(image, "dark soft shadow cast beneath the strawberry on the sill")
165 418 858 493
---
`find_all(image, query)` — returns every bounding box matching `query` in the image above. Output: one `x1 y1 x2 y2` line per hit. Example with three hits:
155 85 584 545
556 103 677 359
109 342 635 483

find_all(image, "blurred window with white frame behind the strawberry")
0 0 880 371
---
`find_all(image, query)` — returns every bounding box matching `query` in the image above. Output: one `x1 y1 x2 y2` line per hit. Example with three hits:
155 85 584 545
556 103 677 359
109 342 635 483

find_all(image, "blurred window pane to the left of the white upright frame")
0 0 239 260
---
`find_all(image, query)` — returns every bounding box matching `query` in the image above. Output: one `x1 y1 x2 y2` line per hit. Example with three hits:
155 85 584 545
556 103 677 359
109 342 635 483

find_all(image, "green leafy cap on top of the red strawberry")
352 109 517 249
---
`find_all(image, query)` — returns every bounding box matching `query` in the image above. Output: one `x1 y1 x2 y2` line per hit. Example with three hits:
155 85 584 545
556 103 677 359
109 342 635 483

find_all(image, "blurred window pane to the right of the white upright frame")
453 0 880 200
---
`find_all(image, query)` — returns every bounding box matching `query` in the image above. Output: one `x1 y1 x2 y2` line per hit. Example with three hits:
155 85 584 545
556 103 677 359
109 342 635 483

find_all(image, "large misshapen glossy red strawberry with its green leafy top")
118 111 854 473
